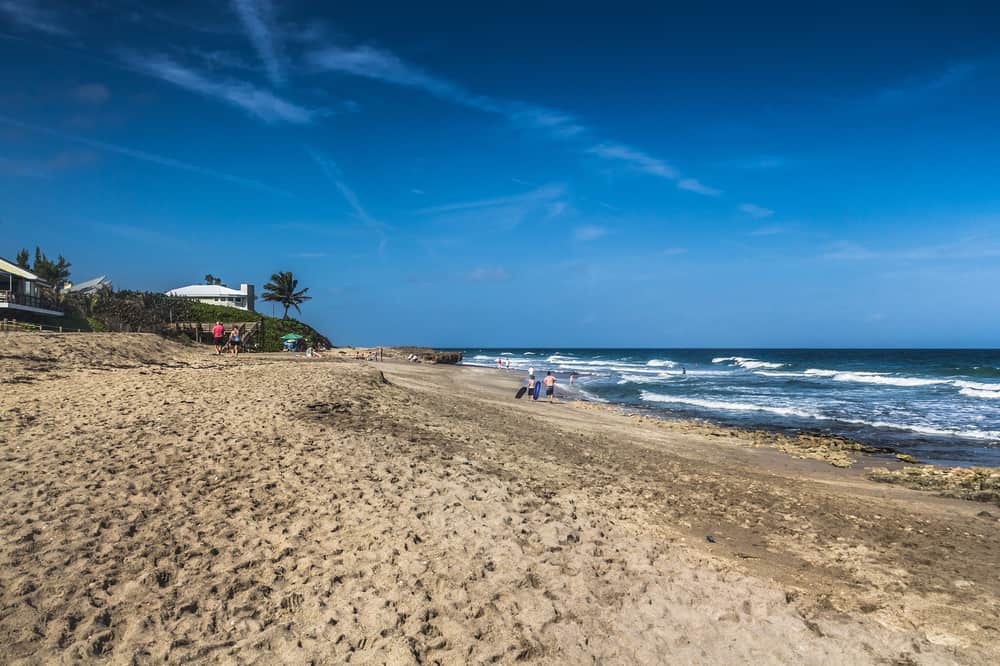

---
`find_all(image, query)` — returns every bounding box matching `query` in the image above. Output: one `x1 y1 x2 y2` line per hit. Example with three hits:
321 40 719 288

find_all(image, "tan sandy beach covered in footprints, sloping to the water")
0 333 1000 664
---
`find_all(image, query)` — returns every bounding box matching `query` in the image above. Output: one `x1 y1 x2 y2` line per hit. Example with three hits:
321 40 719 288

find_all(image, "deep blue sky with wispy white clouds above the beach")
0 0 1000 347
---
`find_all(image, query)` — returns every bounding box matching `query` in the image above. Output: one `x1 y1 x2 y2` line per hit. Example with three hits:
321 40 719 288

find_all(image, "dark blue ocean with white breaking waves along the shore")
463 349 1000 467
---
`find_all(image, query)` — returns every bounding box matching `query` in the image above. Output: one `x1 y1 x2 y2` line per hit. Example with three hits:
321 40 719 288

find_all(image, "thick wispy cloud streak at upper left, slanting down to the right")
123 53 316 124
